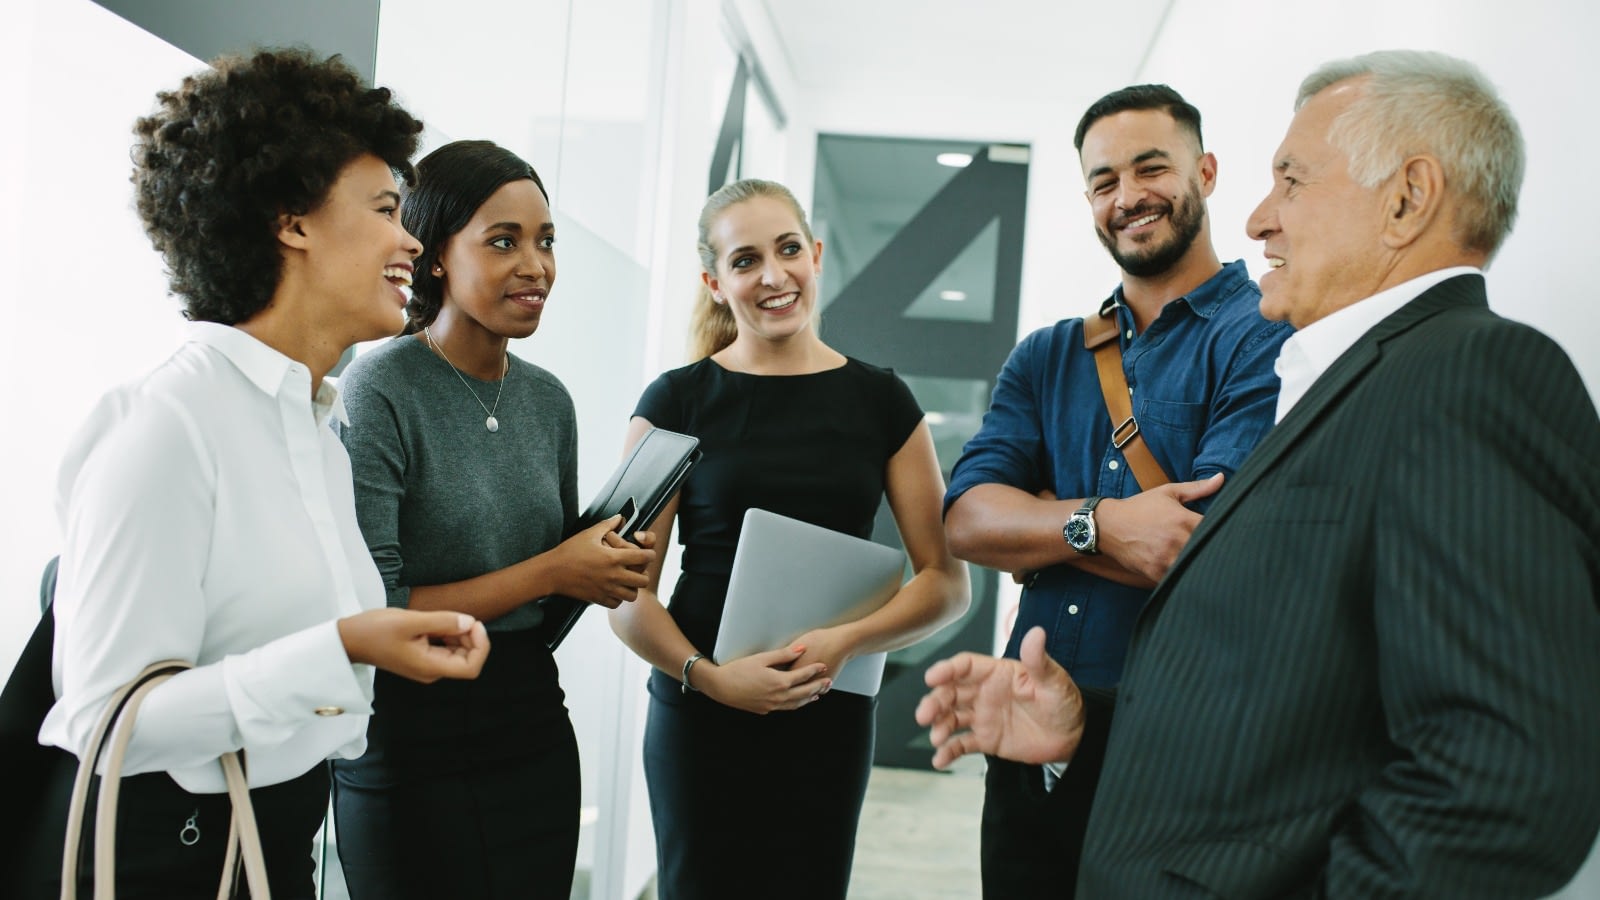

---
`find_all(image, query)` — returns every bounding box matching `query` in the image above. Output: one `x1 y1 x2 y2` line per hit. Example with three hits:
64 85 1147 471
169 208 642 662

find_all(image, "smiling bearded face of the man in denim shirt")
1080 109 1216 277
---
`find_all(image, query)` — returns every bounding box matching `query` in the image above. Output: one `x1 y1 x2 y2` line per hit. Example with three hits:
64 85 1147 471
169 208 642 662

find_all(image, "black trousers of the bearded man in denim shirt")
982 756 1094 900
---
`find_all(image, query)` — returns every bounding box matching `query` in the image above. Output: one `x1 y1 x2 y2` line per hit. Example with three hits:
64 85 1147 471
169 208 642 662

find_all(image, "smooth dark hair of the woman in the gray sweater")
400 141 550 335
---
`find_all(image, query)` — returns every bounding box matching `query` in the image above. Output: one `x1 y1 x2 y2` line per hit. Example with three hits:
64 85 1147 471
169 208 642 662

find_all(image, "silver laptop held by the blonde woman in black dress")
712 509 906 697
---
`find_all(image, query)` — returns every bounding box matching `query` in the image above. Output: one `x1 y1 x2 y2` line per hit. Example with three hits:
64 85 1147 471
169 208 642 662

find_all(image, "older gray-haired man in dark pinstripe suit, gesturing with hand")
917 51 1600 900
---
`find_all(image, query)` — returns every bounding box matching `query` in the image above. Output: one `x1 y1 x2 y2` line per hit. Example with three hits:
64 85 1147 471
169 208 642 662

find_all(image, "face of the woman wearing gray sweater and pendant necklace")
438 178 555 338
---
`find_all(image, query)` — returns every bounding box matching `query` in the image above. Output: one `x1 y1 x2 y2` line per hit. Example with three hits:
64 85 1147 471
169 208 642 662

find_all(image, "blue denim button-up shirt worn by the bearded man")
944 261 1290 687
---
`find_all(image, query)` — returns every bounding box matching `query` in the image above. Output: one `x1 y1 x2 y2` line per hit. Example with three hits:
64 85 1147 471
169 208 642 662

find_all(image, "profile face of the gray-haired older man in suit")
1245 82 1387 328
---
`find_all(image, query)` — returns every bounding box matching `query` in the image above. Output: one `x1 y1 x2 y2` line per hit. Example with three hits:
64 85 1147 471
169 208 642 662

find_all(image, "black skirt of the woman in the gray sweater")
333 631 582 900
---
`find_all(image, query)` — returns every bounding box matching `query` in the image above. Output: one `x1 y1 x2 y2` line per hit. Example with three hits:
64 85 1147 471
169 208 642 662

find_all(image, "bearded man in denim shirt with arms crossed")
944 85 1290 900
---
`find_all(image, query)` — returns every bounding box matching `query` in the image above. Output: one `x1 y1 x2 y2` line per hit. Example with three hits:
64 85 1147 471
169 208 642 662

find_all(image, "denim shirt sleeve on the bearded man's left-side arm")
944 331 1050 512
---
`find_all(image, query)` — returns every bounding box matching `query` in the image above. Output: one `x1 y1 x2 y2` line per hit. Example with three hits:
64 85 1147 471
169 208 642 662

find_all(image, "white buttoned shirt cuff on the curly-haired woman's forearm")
222 621 373 748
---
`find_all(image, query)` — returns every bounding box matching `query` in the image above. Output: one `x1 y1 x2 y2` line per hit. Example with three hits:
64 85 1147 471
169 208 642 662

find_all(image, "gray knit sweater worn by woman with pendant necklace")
339 336 578 631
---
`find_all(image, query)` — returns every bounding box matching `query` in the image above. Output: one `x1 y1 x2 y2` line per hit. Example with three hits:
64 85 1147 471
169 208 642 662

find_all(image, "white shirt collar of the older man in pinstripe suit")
1272 266 1483 423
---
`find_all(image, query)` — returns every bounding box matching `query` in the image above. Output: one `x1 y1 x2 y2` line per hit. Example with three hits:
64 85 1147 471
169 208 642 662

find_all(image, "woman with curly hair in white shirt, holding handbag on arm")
19 51 488 898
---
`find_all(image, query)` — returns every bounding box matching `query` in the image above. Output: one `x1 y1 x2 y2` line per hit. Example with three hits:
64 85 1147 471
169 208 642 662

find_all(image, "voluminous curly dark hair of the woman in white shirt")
133 50 422 325
